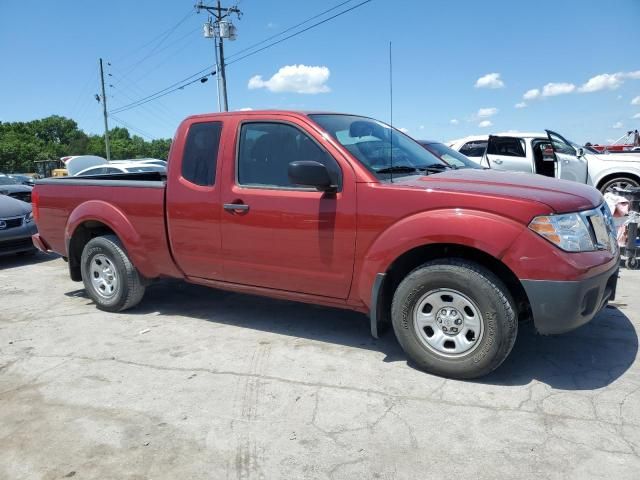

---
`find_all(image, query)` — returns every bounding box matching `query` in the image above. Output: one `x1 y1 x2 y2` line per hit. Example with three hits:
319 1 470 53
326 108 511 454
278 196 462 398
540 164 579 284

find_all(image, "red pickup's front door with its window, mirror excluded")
222 118 356 299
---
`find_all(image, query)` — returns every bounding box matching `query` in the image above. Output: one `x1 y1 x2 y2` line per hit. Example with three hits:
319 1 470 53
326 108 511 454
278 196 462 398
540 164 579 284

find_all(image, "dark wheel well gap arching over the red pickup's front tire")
380 243 531 322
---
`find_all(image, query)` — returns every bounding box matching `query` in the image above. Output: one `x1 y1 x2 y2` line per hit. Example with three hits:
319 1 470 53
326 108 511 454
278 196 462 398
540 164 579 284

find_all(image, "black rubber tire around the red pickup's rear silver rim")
80 235 145 312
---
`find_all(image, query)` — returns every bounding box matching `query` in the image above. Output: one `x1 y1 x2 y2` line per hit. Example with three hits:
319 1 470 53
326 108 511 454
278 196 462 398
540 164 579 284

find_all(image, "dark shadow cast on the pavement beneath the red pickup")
75 280 638 390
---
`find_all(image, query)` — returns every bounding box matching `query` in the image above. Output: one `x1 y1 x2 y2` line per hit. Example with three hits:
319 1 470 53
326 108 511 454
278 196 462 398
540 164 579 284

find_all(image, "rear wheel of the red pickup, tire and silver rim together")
81 235 145 312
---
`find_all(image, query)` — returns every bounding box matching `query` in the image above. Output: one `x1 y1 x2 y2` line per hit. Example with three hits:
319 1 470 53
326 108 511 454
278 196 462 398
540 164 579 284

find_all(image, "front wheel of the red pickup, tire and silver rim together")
391 259 518 378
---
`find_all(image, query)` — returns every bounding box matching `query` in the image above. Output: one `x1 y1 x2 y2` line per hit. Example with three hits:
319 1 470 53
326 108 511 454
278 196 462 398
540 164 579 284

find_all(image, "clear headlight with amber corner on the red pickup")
529 213 596 252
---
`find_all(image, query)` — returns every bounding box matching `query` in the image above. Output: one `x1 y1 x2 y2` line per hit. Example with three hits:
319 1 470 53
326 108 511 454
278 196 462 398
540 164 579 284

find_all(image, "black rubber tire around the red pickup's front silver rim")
391 259 518 379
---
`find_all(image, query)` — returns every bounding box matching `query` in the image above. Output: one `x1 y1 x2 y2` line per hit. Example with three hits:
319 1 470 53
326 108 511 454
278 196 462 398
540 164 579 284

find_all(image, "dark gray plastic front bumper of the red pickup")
522 263 618 335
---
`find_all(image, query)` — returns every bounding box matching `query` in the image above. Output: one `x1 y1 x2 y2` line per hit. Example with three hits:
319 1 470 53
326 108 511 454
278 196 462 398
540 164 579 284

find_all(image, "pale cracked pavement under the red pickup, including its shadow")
0 254 640 480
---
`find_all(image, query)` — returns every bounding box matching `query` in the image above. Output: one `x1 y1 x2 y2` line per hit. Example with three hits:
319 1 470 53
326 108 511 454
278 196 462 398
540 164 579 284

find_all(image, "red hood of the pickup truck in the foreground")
393 169 603 213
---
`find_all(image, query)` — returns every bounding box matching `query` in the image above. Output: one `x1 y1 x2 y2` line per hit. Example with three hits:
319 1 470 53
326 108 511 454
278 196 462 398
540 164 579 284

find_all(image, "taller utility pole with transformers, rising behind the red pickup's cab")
196 0 242 112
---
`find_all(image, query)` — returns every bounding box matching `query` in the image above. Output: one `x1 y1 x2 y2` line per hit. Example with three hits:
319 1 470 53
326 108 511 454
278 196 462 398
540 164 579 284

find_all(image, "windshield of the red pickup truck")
309 114 450 180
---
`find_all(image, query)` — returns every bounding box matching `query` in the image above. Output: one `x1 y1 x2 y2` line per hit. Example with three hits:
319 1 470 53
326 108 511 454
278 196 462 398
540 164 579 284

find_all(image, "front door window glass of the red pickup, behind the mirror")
238 122 340 188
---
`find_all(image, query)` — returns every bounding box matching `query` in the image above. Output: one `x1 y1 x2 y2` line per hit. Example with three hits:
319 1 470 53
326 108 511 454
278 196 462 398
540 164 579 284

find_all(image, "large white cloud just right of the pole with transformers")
248 65 331 94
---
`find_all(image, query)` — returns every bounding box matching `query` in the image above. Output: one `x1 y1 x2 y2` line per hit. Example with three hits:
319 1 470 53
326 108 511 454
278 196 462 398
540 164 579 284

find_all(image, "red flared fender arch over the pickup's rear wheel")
64 200 157 278
